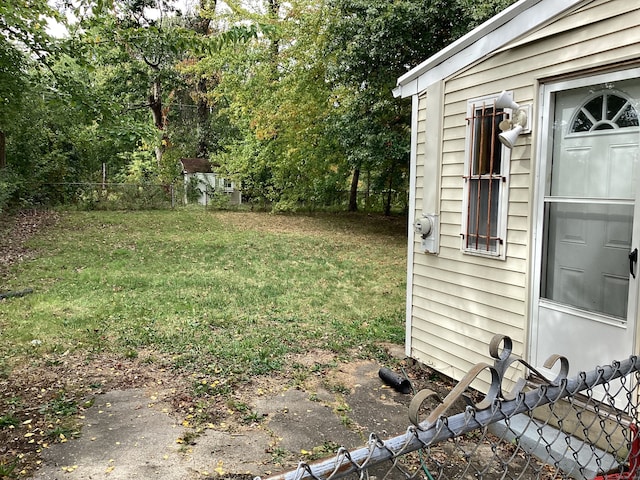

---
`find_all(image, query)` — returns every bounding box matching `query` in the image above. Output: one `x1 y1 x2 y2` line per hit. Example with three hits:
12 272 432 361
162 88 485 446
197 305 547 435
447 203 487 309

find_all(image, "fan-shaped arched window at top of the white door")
569 90 638 133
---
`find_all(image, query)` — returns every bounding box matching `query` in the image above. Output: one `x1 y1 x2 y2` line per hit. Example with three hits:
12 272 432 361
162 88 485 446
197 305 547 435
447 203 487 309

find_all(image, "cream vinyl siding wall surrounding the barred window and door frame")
410 0 640 388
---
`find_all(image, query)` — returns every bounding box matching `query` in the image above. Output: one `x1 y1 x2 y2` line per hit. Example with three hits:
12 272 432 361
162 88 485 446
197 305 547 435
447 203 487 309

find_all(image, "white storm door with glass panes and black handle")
532 75 640 374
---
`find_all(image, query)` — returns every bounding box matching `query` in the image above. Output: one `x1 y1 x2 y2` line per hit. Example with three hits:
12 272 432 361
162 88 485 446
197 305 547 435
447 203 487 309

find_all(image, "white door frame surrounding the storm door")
527 68 640 378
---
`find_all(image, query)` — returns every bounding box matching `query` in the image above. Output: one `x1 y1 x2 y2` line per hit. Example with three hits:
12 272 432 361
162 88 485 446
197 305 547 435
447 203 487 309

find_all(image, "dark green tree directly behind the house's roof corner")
327 0 468 213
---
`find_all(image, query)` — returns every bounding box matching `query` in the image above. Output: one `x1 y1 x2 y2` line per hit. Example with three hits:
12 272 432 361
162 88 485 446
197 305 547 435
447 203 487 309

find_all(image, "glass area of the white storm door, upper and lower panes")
541 85 638 320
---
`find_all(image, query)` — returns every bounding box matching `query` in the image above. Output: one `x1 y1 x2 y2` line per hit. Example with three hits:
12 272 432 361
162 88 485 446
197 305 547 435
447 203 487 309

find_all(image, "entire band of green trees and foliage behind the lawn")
0 0 511 213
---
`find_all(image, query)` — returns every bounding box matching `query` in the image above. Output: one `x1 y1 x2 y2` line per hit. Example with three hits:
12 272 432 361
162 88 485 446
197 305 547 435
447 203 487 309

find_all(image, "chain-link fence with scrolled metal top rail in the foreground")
268 336 640 480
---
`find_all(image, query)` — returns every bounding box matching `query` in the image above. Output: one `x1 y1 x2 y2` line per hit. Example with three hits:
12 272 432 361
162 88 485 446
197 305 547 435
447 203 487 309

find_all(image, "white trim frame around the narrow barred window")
460 92 513 260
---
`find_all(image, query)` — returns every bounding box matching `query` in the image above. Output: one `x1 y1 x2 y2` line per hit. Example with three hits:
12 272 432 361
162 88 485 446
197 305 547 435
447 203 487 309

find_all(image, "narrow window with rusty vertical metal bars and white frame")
462 95 509 256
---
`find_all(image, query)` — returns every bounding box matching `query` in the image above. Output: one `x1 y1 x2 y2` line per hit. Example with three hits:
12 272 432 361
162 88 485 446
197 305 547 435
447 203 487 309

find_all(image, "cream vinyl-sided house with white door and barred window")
394 0 640 392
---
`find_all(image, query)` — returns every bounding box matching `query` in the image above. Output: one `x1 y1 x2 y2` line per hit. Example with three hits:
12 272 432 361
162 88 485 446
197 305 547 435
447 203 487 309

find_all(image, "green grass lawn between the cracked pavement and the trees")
0 209 406 385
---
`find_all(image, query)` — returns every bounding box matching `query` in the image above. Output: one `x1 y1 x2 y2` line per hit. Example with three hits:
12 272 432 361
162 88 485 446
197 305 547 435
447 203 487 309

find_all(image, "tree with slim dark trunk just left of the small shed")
80 0 188 167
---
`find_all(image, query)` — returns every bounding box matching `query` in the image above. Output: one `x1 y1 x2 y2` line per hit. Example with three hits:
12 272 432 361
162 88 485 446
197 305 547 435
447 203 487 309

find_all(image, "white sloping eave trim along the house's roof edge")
393 0 585 98
